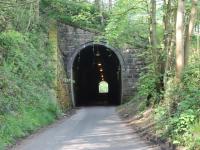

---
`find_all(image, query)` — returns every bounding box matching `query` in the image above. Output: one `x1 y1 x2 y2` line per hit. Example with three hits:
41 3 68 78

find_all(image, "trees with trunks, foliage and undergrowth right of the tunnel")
105 0 200 149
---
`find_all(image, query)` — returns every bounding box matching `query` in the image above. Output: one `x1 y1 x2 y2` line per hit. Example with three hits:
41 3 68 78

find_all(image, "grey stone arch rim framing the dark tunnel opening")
68 41 125 106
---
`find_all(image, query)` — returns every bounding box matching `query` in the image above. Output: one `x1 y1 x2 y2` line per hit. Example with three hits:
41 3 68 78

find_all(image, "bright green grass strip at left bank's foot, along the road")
0 101 61 150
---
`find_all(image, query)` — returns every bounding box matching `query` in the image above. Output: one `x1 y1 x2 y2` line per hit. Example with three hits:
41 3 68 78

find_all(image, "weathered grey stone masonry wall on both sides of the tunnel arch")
58 23 143 100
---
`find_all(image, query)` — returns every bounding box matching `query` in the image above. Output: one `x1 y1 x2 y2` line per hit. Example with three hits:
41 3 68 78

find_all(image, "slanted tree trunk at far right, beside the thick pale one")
184 0 198 65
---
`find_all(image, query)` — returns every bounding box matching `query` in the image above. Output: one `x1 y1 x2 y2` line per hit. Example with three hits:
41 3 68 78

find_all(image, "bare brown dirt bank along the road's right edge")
117 101 179 150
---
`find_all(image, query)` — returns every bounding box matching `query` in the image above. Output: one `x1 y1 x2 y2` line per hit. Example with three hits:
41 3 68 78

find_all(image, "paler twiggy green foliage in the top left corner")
0 0 38 32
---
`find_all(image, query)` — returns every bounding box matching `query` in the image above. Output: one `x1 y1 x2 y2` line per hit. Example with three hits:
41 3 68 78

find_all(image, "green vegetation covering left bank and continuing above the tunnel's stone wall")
0 0 105 149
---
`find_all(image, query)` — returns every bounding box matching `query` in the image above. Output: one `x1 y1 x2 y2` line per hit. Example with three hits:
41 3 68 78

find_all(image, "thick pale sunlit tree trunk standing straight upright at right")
176 0 185 80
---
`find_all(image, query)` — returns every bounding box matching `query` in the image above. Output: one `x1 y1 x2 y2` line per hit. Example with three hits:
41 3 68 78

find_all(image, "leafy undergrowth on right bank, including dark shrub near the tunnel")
133 51 200 150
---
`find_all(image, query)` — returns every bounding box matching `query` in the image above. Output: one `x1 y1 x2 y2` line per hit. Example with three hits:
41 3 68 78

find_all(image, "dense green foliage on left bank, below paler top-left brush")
0 30 61 149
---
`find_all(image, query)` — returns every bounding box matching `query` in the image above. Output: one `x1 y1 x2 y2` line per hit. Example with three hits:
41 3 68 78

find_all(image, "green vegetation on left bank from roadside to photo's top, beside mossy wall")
0 0 62 150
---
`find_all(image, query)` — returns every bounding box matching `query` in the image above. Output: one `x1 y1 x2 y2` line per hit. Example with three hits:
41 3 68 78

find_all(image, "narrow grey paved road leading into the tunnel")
12 107 158 150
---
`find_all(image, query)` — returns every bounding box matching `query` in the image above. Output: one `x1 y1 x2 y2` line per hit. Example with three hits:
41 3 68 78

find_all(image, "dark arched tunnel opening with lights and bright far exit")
72 44 122 106
